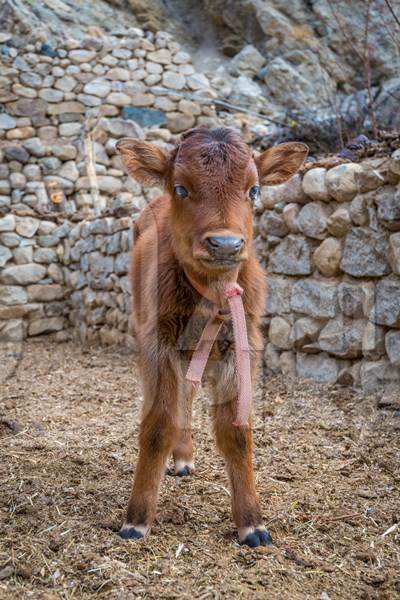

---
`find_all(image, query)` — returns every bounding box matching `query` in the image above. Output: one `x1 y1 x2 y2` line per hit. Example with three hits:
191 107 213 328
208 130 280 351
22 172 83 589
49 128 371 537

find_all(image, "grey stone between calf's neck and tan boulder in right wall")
268 234 312 275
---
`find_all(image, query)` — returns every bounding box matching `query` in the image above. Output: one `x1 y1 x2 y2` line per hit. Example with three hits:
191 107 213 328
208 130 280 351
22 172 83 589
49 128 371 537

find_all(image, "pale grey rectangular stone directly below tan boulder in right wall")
291 279 337 319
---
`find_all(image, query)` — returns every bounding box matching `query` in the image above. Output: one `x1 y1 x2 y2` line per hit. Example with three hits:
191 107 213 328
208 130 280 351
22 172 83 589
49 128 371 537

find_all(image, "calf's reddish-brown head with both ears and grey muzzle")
117 127 308 279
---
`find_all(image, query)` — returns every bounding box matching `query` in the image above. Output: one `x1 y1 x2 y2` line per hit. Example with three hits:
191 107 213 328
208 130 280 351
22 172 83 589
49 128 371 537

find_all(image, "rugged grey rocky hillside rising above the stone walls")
0 0 400 151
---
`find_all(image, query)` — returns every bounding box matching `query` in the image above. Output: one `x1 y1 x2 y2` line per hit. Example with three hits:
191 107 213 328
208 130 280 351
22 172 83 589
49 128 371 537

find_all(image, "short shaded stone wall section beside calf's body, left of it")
63 217 134 347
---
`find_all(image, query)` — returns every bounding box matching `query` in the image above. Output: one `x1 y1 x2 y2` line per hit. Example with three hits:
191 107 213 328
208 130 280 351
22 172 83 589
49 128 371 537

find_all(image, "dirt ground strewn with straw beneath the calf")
0 341 400 600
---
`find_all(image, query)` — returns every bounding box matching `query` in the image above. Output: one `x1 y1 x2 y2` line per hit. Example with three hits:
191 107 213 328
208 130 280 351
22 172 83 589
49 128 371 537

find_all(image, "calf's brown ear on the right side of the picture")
255 142 308 185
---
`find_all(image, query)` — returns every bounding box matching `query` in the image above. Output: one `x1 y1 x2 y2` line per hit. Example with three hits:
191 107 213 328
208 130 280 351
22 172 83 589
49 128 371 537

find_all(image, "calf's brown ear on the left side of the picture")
115 138 168 185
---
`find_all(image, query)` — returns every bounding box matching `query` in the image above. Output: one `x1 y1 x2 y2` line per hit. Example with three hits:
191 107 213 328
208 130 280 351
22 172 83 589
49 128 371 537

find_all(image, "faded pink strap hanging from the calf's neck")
186 283 251 427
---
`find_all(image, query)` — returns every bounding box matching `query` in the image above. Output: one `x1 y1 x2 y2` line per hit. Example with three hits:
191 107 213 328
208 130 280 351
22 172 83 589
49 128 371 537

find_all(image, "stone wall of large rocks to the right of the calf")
256 150 400 391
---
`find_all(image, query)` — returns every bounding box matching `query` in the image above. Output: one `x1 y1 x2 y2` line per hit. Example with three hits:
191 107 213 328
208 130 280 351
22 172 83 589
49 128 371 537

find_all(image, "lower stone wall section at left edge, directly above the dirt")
0 214 69 342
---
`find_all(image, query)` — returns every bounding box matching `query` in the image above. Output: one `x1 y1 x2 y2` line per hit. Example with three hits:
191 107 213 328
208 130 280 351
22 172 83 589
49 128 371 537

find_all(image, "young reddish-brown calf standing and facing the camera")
117 128 307 546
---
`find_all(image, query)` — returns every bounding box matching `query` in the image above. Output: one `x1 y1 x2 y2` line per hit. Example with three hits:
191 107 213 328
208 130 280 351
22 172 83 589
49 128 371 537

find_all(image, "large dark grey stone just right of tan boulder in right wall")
341 227 390 277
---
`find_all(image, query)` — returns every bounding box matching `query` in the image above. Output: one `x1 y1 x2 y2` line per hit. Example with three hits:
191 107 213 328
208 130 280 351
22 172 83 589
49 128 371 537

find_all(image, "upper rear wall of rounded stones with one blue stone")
0 28 216 214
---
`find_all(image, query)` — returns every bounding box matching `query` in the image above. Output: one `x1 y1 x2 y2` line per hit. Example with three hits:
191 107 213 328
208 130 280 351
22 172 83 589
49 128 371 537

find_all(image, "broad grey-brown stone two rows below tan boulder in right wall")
318 316 367 358
